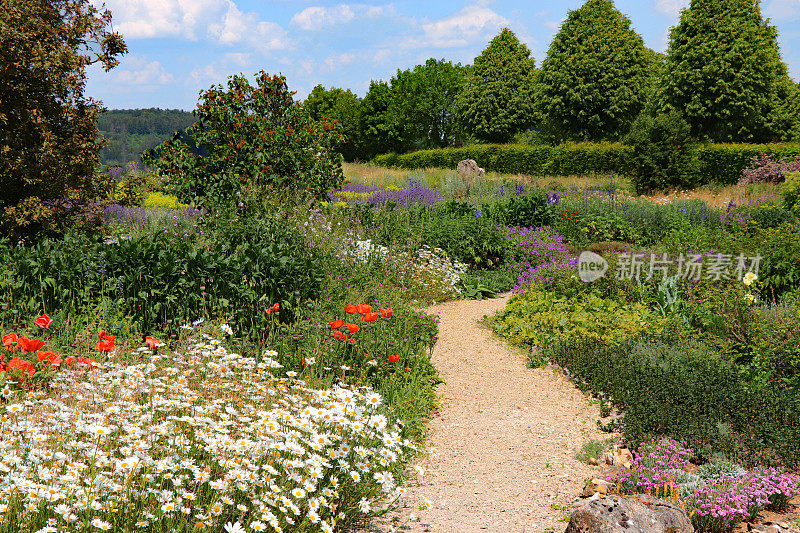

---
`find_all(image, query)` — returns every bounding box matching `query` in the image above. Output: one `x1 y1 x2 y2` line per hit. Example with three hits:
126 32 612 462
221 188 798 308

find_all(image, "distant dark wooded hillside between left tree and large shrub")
97 108 195 166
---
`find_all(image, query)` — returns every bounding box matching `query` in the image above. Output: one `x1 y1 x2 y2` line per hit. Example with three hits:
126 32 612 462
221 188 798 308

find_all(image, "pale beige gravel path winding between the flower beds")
366 295 608 533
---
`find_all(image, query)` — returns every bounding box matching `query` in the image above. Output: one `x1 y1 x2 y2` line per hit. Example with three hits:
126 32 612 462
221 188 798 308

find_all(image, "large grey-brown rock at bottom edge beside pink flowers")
564 494 694 533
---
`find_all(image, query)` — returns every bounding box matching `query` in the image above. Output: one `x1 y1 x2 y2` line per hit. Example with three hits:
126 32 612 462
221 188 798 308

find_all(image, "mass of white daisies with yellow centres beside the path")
0 335 414 531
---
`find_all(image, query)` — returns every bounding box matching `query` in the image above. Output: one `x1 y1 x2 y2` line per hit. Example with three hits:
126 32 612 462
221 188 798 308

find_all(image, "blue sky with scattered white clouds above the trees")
85 0 800 110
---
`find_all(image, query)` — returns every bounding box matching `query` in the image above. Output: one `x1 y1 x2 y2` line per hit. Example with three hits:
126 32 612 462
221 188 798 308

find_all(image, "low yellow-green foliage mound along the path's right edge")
493 290 664 347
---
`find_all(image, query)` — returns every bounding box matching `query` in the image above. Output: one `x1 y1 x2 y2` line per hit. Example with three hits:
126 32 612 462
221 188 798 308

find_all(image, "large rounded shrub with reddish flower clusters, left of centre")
147 71 344 208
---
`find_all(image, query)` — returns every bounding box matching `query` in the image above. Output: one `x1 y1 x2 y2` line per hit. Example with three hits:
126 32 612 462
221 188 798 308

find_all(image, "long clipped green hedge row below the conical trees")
373 143 800 185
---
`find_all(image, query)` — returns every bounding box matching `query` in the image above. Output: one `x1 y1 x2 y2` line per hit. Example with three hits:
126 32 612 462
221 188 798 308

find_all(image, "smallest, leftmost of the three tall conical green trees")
459 28 536 143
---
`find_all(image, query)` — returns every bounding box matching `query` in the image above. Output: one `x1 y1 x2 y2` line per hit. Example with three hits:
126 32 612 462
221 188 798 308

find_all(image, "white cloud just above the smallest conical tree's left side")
416 4 510 48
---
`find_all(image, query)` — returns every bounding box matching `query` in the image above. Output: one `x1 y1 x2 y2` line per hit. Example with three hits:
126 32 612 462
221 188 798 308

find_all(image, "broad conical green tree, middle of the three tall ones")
537 0 657 141
